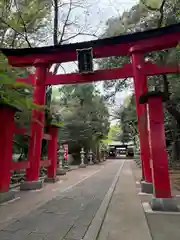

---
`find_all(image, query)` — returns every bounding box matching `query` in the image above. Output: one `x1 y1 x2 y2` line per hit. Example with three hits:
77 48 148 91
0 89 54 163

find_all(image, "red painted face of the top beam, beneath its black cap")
8 32 180 67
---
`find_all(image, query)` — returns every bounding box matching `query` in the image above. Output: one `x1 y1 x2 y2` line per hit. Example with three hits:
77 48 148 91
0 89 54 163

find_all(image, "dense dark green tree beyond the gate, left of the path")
53 84 109 153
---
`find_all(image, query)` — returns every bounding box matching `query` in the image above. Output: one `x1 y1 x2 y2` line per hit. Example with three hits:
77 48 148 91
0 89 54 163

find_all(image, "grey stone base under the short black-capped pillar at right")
151 198 180 212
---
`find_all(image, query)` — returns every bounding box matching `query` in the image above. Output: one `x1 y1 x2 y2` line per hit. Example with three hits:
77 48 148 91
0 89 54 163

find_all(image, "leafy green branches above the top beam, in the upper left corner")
0 0 51 47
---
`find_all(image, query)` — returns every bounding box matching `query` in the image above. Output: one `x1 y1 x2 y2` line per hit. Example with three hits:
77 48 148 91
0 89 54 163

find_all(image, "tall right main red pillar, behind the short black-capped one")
132 53 152 182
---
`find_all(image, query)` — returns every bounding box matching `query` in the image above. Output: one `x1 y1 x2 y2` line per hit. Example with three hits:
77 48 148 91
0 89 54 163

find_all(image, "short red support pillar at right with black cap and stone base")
139 92 178 211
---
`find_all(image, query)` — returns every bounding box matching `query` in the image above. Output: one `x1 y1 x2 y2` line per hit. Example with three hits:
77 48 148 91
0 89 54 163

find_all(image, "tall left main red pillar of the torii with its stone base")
20 65 47 190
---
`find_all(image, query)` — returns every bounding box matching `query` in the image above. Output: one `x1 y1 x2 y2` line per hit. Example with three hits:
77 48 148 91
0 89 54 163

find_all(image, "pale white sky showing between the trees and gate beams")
52 0 138 111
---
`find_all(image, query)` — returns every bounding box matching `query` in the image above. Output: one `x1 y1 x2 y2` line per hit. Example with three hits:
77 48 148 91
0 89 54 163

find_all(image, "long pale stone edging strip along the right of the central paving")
83 160 125 240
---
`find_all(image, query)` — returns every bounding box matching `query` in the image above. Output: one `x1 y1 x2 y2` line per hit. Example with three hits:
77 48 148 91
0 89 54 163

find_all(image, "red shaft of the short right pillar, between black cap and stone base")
148 97 171 198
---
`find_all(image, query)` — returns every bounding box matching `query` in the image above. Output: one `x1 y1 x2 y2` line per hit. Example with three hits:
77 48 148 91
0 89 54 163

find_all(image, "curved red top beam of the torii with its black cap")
0 23 180 67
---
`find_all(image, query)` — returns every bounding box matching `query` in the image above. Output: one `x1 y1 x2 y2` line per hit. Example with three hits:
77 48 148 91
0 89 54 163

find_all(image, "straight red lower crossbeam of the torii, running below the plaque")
16 62 180 85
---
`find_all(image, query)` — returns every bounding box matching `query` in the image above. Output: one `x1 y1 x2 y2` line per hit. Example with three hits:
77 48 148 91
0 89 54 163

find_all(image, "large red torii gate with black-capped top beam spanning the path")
0 24 180 210
